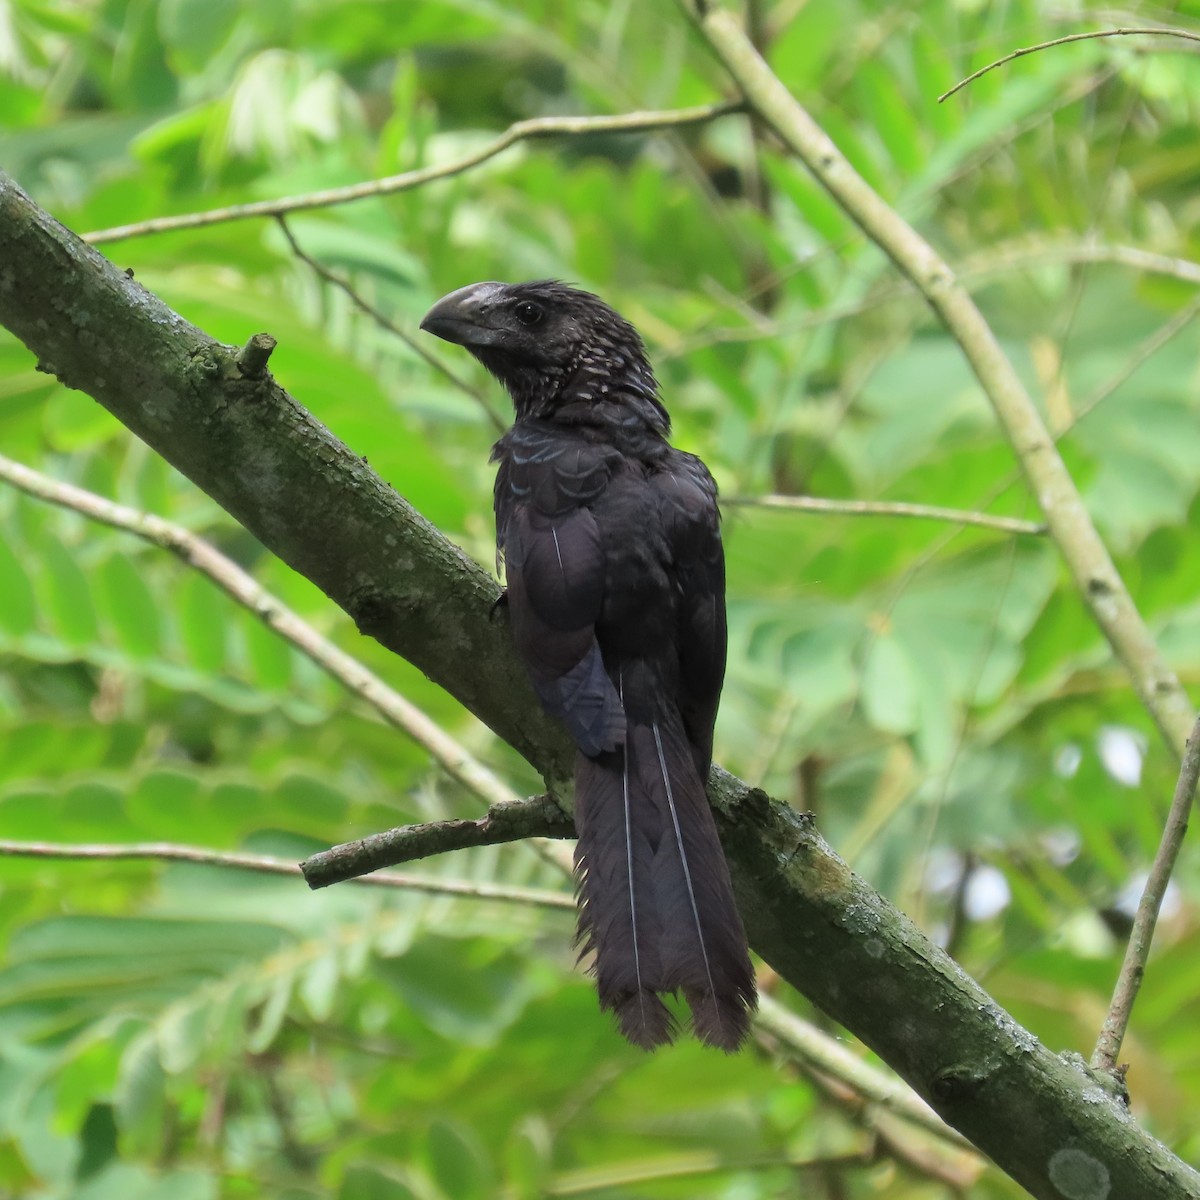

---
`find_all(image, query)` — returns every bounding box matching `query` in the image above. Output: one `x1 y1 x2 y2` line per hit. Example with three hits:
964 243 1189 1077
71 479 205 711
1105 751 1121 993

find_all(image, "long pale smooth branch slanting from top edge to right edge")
683 0 1194 755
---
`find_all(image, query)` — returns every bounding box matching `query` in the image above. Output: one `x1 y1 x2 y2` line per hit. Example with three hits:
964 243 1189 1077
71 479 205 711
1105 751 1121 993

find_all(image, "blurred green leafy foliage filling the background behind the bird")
0 0 1200 1200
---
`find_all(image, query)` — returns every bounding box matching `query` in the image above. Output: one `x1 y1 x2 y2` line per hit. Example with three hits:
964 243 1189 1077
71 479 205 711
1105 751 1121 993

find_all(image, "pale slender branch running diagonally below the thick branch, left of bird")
0 451 530 805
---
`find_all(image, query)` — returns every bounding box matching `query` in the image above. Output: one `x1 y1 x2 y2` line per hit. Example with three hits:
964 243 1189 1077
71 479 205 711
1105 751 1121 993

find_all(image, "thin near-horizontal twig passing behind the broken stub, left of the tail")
0 838 575 908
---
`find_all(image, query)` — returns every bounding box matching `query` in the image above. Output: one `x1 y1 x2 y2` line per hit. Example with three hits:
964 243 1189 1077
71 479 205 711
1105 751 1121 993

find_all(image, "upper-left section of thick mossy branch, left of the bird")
0 174 569 780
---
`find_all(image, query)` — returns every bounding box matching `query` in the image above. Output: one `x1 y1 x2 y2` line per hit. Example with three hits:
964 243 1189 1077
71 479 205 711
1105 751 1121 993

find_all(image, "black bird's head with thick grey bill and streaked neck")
421 280 670 434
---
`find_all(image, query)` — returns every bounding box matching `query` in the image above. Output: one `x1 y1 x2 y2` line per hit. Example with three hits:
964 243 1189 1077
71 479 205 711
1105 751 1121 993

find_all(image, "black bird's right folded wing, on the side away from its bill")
650 451 727 780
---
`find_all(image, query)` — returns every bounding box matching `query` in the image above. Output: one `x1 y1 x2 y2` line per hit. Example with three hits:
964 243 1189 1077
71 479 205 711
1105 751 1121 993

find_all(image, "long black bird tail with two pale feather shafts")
575 716 755 1051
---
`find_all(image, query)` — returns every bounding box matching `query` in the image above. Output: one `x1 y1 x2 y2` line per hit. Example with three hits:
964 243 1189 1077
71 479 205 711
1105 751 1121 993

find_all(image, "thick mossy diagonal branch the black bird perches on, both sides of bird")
0 174 1200 1200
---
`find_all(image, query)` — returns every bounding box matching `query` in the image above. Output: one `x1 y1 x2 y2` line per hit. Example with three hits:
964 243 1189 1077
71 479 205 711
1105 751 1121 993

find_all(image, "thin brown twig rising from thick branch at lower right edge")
1091 718 1200 1070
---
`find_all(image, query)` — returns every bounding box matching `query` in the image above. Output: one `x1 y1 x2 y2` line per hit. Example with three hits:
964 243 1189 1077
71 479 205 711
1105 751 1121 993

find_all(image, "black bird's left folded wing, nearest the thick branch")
497 425 625 755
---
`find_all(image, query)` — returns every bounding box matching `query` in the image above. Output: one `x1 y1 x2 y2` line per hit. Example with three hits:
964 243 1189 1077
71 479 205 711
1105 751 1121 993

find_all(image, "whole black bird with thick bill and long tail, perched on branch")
421 281 755 1051
